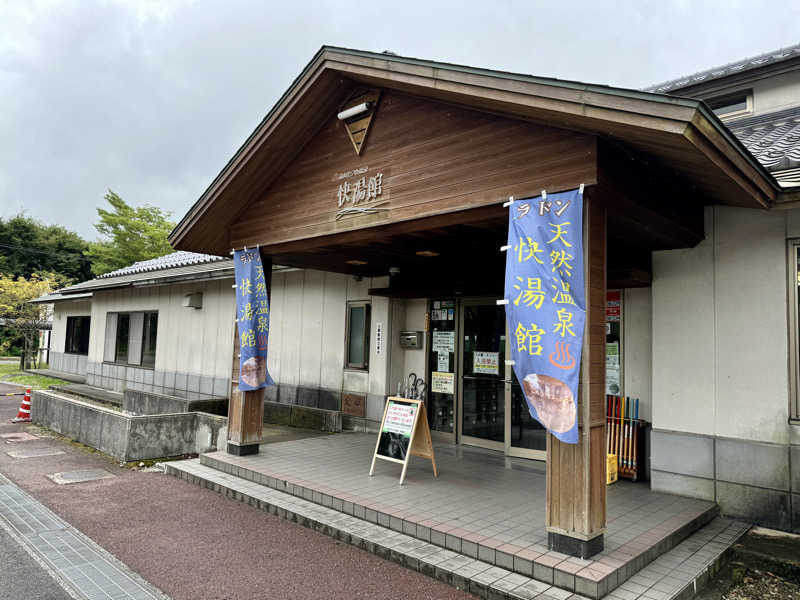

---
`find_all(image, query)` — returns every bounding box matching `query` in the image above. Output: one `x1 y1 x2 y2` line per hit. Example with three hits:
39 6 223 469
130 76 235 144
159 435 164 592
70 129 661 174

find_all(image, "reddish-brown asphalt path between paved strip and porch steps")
0 386 473 600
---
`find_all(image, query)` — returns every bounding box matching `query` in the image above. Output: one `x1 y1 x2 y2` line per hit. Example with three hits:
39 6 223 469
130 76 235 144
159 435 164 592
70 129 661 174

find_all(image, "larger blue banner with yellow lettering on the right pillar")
505 190 586 444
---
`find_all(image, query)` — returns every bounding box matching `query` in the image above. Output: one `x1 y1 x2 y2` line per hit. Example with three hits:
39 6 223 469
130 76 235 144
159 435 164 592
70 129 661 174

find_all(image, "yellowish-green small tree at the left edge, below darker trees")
0 273 70 369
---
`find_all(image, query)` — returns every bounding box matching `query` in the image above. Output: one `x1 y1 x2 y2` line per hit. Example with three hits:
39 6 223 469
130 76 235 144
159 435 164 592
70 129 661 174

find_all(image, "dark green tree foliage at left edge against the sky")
0 214 92 282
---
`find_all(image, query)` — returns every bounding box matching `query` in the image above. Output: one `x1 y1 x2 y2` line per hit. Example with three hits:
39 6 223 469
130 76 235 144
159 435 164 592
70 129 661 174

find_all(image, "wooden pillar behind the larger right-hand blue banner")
547 188 606 558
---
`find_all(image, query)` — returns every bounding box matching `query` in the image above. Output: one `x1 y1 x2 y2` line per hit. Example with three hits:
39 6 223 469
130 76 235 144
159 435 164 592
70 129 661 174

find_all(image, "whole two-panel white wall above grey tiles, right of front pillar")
652 206 791 444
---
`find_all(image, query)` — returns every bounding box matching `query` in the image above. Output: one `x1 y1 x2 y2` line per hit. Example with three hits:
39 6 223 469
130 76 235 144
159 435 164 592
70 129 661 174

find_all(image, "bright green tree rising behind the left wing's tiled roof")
85 190 175 276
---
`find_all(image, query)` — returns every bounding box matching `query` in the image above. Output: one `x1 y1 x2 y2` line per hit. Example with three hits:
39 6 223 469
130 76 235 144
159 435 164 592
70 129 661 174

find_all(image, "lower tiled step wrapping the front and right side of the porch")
166 459 749 600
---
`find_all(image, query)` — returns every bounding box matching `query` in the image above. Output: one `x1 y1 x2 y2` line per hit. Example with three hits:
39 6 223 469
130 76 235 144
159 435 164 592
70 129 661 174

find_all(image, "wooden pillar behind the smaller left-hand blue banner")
227 253 272 456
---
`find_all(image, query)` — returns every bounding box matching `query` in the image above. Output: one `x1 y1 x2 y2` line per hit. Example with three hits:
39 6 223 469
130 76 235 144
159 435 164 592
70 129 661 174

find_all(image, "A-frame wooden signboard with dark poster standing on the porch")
369 397 439 485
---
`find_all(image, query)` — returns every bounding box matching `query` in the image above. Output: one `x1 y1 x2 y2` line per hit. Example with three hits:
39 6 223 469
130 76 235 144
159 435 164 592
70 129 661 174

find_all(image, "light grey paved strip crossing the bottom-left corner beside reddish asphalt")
0 475 168 600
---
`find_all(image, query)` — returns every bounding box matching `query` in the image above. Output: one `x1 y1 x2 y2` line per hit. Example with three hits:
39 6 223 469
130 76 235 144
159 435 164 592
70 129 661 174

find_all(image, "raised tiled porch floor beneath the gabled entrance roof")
200 433 718 597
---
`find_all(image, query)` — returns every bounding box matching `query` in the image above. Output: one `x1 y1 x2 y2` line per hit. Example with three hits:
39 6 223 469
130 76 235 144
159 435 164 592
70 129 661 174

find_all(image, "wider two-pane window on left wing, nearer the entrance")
103 311 158 368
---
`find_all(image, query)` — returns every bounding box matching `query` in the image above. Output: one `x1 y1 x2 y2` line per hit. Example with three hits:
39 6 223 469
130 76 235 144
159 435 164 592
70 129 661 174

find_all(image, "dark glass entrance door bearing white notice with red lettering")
459 300 506 450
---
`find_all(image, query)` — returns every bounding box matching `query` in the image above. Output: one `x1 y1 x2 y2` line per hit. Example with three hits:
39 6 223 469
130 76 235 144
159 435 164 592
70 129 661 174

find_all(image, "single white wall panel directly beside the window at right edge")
715 206 789 443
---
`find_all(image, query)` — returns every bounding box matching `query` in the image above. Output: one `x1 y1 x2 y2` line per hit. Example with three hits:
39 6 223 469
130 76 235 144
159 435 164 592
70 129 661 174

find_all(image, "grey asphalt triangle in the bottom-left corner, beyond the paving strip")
0 528 71 600
